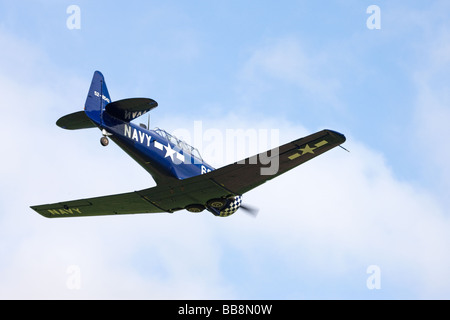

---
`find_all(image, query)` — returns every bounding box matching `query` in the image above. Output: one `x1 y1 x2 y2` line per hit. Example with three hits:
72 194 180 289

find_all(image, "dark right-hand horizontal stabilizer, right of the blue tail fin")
105 98 158 121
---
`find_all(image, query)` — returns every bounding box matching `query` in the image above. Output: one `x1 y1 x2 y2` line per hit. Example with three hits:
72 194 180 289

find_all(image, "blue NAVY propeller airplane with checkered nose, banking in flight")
31 71 346 218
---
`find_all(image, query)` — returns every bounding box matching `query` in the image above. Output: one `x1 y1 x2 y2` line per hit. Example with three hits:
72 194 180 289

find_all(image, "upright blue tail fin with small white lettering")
84 71 111 124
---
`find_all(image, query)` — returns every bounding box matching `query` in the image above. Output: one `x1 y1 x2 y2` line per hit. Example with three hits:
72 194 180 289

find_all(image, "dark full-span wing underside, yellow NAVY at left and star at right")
31 130 345 218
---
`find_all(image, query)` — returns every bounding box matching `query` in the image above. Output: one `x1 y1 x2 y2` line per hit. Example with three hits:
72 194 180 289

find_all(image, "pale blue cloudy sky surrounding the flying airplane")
0 0 450 300
